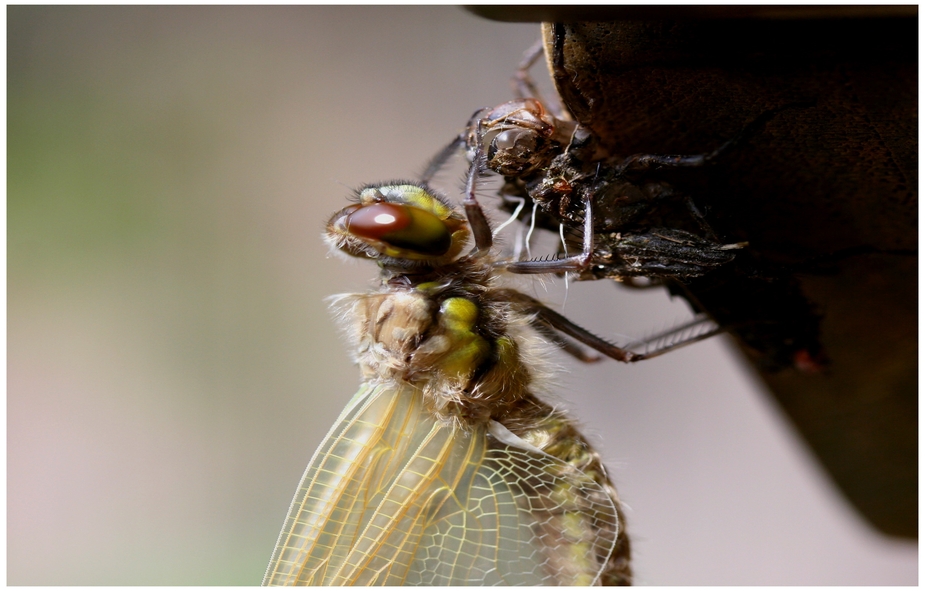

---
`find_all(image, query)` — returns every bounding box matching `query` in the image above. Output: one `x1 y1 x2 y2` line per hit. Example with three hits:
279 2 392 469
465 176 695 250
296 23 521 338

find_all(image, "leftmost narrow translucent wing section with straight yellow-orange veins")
263 383 438 585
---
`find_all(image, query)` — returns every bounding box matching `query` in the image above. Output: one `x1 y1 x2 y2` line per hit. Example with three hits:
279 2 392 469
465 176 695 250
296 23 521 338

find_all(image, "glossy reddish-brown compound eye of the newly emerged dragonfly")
344 203 452 256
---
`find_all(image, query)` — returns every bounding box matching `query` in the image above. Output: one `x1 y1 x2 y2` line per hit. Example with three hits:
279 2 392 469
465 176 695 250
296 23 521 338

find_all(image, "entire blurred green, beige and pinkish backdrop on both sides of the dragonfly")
7 6 918 585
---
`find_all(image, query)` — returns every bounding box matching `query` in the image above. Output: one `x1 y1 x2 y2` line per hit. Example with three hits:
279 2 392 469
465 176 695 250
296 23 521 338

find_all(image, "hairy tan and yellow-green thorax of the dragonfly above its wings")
335 282 534 429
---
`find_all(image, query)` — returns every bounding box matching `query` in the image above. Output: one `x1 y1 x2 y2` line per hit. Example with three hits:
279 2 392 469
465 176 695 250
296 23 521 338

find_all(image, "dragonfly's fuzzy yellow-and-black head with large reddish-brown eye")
325 181 469 269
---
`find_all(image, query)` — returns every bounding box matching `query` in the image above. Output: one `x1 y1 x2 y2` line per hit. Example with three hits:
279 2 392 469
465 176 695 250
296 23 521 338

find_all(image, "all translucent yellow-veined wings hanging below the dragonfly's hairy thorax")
264 383 618 585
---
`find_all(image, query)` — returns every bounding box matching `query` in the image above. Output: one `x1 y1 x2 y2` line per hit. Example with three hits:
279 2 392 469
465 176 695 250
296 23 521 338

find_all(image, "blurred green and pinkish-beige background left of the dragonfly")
7 6 537 585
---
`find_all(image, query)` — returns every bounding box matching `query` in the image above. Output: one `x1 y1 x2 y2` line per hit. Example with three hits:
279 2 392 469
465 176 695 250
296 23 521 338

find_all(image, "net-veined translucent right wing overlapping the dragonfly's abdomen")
407 423 619 585
